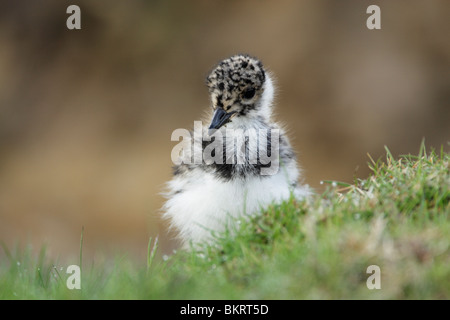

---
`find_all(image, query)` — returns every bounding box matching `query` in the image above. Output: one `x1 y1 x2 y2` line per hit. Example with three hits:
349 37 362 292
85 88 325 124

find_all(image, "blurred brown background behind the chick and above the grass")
0 0 450 262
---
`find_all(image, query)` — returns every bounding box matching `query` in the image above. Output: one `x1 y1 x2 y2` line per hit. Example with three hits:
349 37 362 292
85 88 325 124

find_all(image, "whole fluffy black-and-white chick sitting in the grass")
163 55 310 244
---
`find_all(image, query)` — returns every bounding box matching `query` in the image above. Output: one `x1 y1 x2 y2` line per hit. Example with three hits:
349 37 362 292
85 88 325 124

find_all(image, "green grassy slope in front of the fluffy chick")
0 145 450 299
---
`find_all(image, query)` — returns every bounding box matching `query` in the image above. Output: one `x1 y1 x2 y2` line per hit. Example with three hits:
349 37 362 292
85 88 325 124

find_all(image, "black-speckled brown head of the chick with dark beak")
206 55 268 129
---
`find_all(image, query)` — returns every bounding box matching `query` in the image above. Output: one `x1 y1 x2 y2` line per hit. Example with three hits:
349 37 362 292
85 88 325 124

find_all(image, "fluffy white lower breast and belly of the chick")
163 167 309 243
